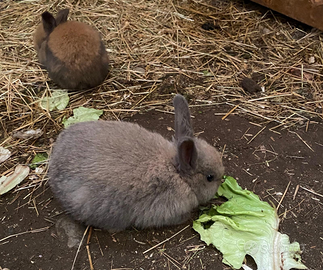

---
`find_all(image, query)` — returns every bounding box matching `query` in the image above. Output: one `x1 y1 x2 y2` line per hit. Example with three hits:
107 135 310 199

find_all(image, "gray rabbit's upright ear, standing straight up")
173 95 193 141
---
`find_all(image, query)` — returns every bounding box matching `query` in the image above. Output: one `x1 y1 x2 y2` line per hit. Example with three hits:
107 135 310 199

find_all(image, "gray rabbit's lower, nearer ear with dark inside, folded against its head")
177 137 197 173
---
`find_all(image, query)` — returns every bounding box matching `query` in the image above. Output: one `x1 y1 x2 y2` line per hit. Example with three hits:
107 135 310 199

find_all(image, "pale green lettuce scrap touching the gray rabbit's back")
63 107 103 128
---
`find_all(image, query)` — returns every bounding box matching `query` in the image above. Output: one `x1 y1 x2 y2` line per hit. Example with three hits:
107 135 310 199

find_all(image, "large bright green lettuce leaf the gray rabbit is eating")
193 177 307 270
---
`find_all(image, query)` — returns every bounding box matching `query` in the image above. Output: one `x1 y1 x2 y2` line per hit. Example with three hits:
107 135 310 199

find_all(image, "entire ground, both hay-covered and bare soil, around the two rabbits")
0 0 323 270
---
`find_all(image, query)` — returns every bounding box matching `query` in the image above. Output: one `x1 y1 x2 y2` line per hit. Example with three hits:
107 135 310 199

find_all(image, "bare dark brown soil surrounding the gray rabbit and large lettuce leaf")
0 107 323 270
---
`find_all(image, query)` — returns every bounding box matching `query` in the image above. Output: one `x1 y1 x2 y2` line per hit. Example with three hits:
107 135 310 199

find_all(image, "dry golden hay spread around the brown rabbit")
0 0 323 192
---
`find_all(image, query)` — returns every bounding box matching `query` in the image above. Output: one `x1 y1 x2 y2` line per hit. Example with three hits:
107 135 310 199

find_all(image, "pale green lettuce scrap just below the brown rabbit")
39 90 70 111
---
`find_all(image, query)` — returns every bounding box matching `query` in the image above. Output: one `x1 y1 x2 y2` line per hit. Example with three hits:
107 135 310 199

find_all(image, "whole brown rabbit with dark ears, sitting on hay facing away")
34 9 109 89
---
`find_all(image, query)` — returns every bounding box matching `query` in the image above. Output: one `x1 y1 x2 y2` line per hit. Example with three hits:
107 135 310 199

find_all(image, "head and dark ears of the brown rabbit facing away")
34 9 69 52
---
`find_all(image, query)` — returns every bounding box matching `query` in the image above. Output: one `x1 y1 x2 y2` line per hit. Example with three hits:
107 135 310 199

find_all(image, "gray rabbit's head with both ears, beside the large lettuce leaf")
174 95 224 204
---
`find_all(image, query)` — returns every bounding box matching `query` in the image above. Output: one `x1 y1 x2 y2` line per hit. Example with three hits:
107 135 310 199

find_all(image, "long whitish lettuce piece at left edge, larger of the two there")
0 165 29 195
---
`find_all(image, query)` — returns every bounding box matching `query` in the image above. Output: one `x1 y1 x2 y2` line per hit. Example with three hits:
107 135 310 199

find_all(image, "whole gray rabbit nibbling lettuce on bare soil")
49 95 224 231
